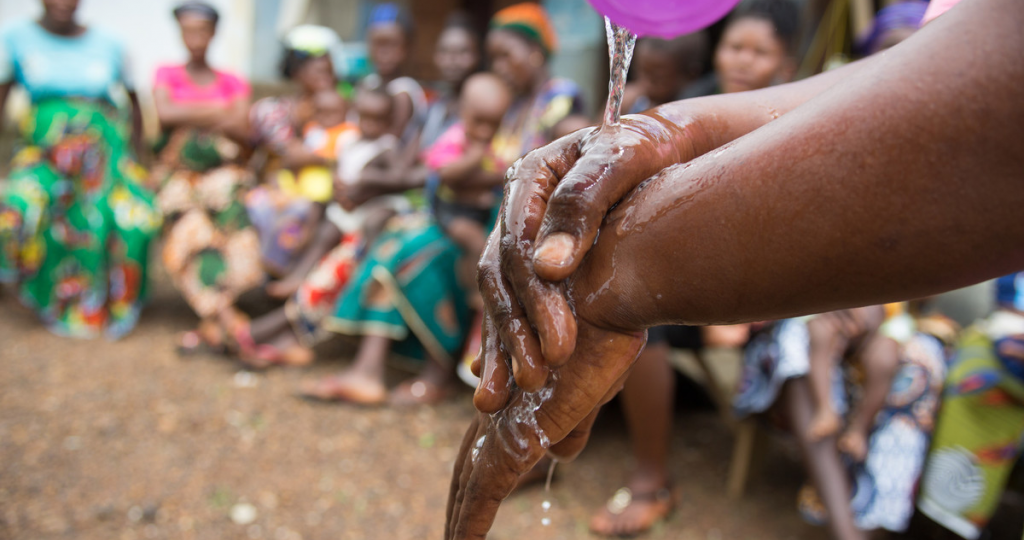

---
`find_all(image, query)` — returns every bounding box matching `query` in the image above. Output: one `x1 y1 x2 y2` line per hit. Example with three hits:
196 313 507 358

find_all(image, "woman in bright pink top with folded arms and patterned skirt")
151 2 264 352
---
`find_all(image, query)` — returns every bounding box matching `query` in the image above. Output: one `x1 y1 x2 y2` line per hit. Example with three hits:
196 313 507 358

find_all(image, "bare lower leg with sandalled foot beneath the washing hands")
590 341 676 536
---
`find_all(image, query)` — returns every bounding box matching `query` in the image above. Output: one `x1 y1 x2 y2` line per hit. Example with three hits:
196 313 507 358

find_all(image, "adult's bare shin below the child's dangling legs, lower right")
780 377 865 540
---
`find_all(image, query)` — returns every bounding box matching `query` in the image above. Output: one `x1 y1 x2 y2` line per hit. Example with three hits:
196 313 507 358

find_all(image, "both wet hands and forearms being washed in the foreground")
447 0 1024 538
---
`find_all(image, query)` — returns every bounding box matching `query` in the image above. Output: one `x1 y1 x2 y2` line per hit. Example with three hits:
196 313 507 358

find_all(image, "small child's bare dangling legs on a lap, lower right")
807 304 901 462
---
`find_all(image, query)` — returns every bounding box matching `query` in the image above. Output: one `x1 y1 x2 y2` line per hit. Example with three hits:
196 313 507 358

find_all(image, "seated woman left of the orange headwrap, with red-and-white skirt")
220 17 480 367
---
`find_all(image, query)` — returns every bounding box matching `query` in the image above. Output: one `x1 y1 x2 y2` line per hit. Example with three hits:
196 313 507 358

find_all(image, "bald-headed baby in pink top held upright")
423 73 512 306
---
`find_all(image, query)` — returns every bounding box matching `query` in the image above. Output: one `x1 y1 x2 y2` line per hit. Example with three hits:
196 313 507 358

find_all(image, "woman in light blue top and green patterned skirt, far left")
0 1 161 338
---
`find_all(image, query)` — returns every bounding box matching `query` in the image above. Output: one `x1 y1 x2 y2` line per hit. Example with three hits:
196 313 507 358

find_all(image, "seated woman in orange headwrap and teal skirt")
292 4 582 404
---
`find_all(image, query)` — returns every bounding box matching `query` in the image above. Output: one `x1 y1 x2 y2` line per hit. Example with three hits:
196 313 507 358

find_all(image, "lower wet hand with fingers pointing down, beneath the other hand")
445 322 645 540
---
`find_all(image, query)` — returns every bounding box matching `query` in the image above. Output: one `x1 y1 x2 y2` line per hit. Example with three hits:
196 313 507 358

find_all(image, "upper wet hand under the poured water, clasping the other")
479 114 696 390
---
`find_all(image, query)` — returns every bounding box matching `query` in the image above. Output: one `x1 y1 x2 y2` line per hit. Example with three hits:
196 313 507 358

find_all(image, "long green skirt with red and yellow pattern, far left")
0 99 161 338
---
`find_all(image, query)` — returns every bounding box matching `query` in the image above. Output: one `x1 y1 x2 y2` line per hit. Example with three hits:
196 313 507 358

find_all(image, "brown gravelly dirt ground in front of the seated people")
0 279 843 540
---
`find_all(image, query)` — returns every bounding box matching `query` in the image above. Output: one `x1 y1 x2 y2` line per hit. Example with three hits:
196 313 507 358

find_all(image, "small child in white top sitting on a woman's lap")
327 87 409 245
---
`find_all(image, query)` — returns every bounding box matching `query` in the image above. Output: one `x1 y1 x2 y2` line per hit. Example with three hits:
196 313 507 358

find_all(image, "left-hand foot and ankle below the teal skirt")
301 335 391 405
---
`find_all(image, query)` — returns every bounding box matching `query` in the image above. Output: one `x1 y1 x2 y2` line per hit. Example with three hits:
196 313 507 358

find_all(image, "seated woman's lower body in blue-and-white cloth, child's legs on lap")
735 305 945 538
